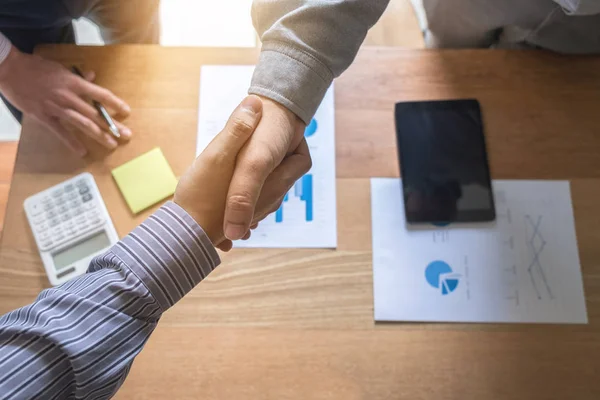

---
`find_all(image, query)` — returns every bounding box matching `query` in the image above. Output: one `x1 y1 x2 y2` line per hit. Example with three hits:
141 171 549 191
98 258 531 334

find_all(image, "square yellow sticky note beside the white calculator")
112 147 177 213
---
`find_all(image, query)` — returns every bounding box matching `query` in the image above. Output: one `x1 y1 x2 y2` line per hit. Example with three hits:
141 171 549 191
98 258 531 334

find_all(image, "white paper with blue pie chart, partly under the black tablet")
371 178 587 323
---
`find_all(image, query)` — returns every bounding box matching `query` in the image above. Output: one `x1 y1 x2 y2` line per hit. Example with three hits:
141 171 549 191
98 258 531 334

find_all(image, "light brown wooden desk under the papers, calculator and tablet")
0 46 600 400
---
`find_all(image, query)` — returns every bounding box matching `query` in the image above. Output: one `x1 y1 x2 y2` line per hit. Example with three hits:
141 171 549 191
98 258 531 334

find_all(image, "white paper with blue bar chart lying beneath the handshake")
196 65 337 248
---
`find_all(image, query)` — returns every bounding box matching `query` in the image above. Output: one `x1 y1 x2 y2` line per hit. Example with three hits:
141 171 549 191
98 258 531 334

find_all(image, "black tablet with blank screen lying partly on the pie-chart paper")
396 100 496 224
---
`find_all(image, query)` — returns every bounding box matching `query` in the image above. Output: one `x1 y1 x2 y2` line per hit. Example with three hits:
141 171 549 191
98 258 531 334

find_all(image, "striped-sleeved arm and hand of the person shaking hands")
0 96 310 400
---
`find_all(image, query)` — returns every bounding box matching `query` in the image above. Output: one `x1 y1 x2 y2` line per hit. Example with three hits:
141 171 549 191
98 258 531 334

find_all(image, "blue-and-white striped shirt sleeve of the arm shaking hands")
0 202 220 399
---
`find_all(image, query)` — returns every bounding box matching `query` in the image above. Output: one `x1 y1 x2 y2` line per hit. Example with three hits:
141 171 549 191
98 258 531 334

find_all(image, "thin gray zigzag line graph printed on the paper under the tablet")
525 215 554 300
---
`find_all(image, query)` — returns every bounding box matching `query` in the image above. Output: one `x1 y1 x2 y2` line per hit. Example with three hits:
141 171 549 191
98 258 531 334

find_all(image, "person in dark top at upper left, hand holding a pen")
0 0 160 156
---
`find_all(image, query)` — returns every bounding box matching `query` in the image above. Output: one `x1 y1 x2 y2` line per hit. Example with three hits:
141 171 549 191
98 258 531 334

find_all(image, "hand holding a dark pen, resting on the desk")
0 47 131 156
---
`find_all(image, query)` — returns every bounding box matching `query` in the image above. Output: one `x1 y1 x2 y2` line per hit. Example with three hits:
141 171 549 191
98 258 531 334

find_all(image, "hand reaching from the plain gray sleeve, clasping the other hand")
223 98 311 240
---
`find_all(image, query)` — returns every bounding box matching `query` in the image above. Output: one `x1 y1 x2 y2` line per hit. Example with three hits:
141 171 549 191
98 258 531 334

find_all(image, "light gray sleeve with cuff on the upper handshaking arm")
249 0 389 123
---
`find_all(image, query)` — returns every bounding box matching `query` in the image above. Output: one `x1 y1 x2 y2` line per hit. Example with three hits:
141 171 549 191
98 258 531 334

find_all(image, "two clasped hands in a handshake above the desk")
173 96 311 251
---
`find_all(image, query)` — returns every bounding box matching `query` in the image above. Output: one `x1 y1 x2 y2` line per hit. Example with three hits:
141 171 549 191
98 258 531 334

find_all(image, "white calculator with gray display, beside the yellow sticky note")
24 173 119 286
